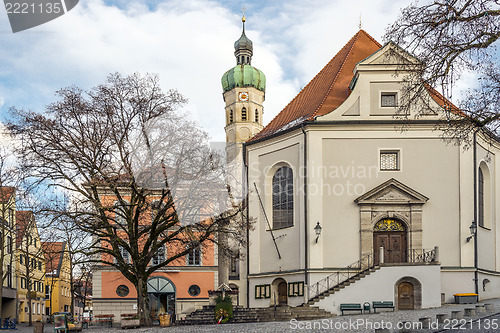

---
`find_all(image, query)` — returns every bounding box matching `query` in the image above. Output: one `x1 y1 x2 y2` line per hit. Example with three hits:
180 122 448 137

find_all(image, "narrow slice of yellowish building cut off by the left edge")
0 186 17 319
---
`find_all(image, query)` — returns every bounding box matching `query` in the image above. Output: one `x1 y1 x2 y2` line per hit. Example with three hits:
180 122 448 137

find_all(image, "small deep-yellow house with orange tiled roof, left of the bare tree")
42 242 71 315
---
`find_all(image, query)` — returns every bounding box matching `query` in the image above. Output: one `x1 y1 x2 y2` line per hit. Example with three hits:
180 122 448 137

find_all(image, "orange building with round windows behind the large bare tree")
92 191 217 321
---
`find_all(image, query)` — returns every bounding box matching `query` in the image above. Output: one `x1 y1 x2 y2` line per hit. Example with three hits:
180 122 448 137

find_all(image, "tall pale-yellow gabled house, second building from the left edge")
16 211 45 323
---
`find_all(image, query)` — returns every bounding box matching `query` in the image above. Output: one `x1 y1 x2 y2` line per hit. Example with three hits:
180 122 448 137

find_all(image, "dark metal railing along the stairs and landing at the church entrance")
309 248 437 300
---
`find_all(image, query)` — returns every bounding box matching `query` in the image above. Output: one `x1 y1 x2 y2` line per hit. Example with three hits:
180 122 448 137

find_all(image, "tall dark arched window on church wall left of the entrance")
273 166 293 229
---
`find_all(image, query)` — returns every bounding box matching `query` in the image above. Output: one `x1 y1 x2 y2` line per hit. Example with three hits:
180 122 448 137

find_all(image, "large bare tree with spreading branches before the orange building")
10 74 246 324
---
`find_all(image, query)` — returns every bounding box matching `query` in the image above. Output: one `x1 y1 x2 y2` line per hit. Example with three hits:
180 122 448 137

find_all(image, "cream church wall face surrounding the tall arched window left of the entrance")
248 133 305 274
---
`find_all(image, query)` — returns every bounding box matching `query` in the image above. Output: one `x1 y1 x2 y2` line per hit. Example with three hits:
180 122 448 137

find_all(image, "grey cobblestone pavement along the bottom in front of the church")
13 298 500 333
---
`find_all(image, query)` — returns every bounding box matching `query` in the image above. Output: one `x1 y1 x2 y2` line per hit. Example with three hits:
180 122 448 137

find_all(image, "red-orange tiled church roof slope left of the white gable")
249 30 382 141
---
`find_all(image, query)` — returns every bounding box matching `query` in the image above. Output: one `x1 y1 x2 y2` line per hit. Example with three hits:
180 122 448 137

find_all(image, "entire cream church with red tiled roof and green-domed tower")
219 20 500 314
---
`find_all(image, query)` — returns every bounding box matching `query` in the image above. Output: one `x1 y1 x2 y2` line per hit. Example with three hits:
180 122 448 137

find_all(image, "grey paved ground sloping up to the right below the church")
10 298 500 333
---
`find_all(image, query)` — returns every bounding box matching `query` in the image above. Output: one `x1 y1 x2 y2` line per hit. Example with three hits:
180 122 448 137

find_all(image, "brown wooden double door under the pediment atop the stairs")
373 231 406 264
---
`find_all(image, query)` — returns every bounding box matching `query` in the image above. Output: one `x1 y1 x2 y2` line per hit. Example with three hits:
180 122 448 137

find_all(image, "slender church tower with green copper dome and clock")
221 16 266 176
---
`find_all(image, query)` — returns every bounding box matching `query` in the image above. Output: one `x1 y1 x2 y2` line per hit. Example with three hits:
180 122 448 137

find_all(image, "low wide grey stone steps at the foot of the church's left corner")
176 305 334 325
